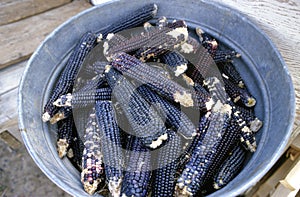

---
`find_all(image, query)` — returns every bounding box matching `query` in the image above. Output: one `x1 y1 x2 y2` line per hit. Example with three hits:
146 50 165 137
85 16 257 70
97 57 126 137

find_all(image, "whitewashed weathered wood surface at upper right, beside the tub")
214 0 300 141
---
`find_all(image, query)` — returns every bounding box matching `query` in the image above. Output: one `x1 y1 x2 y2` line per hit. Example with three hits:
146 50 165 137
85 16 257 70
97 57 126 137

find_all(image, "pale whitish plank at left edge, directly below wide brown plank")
0 61 27 95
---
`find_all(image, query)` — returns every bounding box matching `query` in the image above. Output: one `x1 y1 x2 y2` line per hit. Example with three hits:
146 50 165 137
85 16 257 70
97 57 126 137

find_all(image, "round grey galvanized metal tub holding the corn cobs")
18 0 295 196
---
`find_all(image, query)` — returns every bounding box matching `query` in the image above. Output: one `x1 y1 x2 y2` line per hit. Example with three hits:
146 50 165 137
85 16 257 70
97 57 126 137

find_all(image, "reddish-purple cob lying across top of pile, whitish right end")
103 21 188 60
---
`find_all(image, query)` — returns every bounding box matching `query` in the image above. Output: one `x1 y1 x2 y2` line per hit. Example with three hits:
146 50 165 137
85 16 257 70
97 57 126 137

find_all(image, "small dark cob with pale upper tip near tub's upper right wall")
196 28 218 57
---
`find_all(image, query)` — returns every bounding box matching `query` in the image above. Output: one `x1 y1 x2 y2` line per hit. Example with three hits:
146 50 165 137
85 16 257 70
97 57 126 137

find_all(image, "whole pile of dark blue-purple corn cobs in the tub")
42 4 262 197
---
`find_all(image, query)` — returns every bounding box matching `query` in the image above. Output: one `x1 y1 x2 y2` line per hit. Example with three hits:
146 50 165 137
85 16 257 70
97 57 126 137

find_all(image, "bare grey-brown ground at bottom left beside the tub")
0 140 70 197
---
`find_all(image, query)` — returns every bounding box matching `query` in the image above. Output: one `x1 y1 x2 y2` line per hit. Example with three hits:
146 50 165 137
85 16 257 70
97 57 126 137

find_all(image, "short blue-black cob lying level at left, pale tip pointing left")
53 87 112 108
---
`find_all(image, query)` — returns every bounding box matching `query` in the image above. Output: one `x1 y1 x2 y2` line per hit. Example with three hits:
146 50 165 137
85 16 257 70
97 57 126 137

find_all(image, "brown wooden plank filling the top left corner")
0 0 71 25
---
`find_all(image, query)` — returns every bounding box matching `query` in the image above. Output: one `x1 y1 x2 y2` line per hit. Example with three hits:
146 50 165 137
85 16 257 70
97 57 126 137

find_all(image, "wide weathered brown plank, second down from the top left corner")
0 1 91 69
